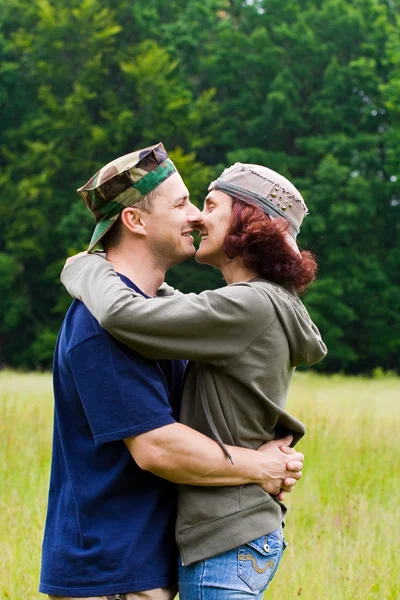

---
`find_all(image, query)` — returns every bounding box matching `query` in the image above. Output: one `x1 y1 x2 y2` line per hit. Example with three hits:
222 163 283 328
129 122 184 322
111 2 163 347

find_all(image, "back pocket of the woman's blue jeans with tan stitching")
238 527 283 593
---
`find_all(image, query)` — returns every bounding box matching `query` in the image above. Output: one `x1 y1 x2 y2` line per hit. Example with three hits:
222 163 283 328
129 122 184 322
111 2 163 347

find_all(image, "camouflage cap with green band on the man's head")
77 142 176 252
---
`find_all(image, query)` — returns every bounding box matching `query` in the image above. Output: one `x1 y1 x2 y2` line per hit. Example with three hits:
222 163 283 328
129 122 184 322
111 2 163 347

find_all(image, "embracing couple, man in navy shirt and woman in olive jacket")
40 143 326 600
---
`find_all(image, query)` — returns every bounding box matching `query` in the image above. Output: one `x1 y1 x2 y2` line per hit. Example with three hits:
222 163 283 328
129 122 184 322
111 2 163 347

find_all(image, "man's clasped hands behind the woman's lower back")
258 436 304 500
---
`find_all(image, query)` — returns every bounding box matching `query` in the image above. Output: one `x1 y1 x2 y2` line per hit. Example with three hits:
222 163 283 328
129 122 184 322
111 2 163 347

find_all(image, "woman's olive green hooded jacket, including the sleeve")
62 256 326 565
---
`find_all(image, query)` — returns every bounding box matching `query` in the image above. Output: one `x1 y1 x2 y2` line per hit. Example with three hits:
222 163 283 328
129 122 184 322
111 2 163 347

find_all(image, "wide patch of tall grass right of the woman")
272 373 400 600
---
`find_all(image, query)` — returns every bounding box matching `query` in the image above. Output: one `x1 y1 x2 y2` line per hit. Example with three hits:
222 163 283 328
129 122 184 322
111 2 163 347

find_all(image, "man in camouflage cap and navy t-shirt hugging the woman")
40 144 303 600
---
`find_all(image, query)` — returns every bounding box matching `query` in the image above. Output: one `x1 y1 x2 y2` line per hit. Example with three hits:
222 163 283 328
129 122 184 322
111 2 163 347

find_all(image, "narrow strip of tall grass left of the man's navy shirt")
0 372 52 600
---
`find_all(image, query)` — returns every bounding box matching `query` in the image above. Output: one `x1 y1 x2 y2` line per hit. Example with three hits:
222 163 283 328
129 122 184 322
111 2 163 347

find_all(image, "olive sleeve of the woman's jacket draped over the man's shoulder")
61 255 274 366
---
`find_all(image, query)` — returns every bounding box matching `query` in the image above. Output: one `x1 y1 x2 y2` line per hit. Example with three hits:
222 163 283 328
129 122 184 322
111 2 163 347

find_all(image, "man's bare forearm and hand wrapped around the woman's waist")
125 423 295 493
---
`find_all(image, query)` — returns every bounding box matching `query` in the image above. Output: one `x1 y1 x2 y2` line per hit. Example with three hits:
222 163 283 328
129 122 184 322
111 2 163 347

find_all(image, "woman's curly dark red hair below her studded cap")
224 198 317 292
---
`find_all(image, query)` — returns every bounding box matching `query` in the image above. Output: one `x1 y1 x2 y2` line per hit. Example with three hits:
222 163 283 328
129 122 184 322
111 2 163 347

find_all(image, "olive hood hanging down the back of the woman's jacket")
252 279 327 367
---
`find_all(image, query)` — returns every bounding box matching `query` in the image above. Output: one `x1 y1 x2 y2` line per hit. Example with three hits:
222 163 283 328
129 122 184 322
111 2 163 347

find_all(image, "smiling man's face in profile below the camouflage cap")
143 173 201 268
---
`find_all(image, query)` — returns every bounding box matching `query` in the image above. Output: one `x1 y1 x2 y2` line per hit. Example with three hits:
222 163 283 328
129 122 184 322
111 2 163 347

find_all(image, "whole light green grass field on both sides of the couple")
0 372 400 600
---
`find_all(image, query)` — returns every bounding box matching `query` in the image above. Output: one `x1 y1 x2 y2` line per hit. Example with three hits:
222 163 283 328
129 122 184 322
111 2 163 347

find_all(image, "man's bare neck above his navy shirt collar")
107 247 165 297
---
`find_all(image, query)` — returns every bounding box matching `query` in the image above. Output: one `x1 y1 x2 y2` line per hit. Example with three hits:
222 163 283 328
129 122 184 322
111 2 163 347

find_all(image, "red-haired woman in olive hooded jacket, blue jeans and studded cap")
63 163 326 600
